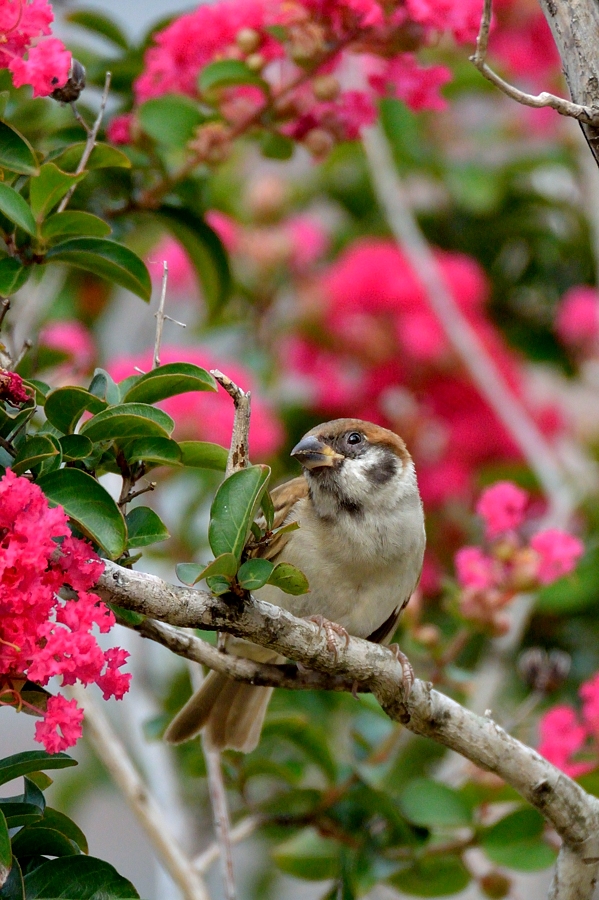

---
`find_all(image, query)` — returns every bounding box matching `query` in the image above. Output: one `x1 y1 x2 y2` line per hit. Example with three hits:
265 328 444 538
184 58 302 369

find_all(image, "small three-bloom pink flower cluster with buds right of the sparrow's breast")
455 481 584 634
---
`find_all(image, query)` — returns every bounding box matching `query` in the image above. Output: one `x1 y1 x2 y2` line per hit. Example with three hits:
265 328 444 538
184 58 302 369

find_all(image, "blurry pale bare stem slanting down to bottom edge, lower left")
71 685 209 900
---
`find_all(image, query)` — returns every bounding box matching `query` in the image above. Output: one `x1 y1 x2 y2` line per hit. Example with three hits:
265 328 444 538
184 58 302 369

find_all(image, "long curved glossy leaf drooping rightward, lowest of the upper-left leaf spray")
45 237 152 300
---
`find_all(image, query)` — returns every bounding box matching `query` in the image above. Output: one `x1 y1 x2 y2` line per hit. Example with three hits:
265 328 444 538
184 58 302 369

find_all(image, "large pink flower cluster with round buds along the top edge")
109 0 480 162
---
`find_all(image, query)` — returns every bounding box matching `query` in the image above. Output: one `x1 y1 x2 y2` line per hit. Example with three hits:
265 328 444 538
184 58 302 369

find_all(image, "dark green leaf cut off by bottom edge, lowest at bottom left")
25 856 139 900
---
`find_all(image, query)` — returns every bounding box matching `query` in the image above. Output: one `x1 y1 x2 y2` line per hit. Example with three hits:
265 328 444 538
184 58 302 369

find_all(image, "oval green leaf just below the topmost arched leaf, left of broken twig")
80 403 175 443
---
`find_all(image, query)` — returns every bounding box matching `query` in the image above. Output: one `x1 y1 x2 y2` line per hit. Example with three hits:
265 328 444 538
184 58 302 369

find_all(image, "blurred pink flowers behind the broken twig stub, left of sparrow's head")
107 346 285 459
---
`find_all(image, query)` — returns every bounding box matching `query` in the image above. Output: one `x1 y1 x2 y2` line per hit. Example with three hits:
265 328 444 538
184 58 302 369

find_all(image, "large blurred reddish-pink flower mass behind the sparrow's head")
280 238 560 509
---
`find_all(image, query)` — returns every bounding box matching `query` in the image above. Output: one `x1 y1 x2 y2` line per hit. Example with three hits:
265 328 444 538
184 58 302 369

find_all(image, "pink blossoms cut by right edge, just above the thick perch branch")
539 674 599 778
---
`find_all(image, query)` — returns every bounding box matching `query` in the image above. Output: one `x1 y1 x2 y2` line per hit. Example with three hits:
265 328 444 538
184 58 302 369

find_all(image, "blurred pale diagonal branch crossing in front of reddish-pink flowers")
364 126 574 523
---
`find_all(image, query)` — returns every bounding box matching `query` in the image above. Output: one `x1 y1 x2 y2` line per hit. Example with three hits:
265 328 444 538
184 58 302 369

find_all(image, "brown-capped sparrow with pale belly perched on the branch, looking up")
164 419 426 753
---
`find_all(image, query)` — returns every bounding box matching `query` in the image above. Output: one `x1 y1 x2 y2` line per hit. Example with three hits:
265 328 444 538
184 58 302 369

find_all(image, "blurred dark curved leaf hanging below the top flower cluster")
153 206 231 314
